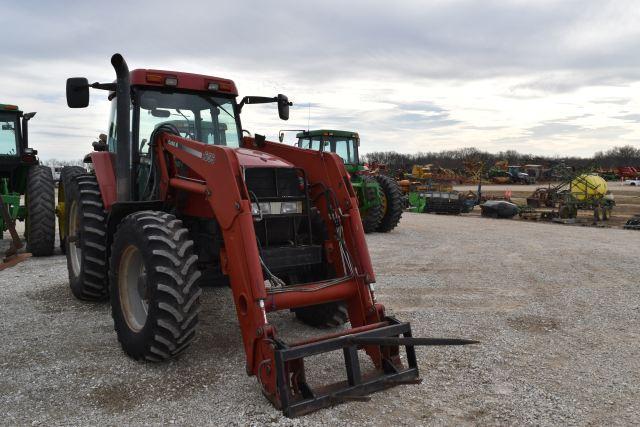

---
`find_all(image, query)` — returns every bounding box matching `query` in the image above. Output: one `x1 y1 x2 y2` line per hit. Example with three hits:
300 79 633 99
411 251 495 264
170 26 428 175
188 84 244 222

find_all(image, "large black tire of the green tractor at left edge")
25 165 56 256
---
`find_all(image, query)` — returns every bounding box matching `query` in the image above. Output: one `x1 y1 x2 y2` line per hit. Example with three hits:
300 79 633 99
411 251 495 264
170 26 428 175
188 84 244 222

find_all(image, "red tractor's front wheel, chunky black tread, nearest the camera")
109 211 202 362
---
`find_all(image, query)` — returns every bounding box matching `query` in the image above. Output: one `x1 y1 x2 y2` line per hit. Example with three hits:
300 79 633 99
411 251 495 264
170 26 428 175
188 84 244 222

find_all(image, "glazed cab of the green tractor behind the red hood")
296 130 364 173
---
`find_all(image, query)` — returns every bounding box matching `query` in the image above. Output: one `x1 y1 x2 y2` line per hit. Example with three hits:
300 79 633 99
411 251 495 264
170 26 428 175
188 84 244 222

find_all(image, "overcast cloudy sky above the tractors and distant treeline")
0 0 640 159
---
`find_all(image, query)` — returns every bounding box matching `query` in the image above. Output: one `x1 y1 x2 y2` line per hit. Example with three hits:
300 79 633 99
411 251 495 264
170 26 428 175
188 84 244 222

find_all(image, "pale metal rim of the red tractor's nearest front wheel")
118 245 149 332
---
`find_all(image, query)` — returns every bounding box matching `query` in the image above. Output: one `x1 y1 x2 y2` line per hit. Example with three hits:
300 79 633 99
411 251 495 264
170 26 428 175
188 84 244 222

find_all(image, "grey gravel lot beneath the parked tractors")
0 214 640 425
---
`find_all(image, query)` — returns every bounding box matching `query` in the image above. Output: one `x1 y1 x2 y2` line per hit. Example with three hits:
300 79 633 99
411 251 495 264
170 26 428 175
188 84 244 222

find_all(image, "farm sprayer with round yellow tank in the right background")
521 173 615 222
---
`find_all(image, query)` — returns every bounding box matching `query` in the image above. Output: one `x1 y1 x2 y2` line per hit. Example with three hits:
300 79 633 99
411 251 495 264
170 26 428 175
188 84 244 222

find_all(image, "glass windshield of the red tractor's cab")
138 90 241 153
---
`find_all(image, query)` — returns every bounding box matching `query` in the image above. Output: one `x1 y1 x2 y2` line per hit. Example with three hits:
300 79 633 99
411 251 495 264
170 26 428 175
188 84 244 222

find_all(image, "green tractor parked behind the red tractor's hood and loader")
279 129 403 233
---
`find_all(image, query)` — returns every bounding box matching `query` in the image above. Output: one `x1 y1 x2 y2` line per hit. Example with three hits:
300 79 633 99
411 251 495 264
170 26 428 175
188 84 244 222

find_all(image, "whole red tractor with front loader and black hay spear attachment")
65 54 476 416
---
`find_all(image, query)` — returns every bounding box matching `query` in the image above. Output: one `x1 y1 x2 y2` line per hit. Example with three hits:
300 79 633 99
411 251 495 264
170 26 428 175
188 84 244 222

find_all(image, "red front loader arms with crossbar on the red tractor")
156 133 383 406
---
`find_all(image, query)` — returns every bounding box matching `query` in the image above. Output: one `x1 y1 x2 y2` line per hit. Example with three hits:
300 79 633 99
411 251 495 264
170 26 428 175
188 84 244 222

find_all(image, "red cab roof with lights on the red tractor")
130 69 238 96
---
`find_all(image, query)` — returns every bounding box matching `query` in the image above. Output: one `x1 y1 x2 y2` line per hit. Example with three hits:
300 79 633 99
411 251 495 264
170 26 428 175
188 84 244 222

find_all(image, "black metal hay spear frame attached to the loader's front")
275 317 477 417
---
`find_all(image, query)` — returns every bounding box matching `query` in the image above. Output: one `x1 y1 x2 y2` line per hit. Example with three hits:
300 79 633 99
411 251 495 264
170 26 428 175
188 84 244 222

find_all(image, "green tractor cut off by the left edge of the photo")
0 104 56 256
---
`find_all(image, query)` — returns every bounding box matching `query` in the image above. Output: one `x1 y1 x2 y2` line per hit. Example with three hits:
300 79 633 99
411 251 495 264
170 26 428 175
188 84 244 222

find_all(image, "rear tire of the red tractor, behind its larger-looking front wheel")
65 174 108 301
